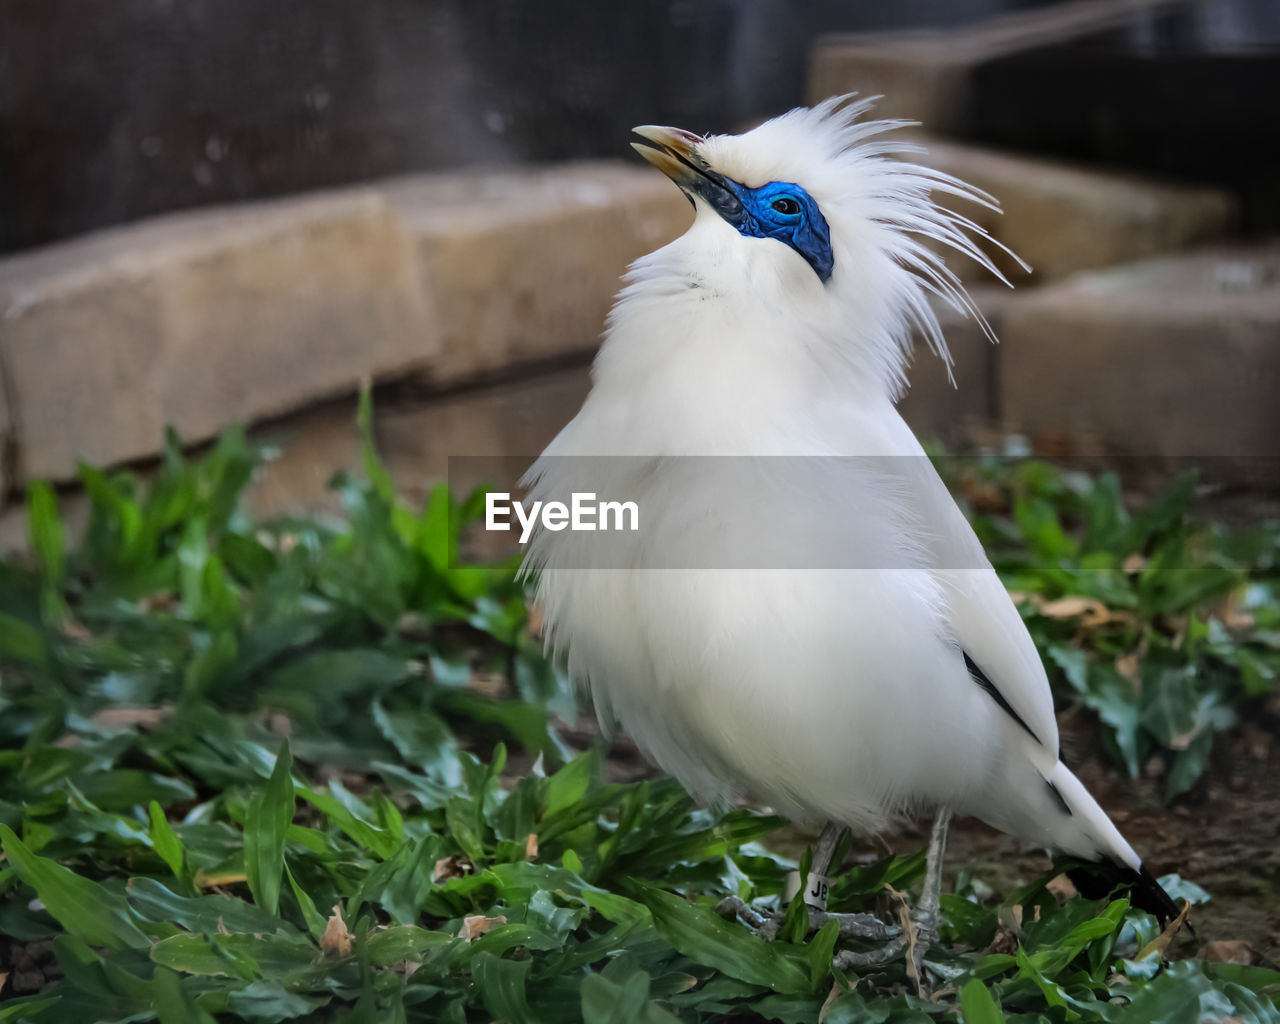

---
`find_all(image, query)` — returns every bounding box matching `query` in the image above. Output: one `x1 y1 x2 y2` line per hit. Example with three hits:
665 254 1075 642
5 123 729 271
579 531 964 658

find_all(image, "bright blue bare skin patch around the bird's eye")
681 166 836 284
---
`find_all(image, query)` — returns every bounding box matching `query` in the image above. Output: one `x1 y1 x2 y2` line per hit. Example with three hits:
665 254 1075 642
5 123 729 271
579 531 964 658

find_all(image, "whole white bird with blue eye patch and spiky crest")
526 97 1172 967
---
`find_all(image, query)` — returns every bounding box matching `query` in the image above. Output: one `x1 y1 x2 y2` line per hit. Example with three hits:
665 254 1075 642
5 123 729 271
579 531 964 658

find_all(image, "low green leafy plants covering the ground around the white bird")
0 401 1280 1024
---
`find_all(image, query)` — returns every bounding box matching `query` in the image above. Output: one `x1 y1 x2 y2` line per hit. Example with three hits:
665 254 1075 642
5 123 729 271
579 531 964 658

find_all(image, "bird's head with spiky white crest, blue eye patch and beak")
632 97 1024 389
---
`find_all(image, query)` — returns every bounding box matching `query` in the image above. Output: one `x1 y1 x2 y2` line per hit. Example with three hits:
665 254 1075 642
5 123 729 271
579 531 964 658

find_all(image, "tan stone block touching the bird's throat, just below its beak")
384 163 692 385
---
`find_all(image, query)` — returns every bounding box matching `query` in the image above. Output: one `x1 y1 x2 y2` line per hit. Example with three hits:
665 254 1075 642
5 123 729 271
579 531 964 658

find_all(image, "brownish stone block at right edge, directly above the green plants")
1000 243 1280 460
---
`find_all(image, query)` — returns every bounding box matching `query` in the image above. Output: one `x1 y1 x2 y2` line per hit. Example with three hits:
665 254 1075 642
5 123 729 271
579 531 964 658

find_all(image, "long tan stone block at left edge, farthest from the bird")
0 191 433 479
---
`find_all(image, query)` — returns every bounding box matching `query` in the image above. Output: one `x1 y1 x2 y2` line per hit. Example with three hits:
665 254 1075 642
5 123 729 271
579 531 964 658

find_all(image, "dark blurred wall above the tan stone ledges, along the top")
0 0 1280 252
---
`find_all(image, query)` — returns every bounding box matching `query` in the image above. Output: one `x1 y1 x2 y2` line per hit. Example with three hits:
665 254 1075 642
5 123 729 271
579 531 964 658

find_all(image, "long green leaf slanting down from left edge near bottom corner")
0 824 151 950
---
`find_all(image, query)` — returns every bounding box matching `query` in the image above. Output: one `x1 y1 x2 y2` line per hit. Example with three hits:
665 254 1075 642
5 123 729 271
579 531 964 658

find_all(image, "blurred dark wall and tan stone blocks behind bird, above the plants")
0 0 1280 527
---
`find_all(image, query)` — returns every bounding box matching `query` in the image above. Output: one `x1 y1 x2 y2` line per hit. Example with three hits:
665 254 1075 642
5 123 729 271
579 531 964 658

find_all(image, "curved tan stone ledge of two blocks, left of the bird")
0 164 689 485
